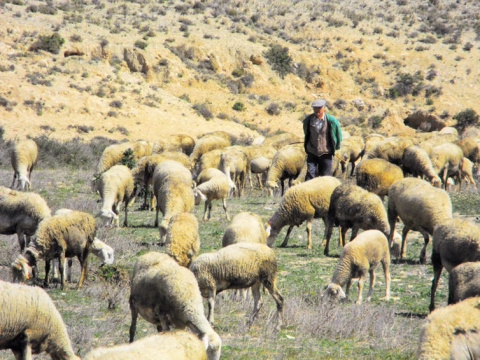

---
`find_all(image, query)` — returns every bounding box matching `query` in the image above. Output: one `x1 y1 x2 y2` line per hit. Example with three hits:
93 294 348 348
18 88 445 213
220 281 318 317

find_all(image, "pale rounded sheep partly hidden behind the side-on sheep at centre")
222 212 267 247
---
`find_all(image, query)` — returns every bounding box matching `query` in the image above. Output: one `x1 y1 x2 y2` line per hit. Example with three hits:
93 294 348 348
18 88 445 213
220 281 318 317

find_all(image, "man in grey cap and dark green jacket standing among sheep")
303 99 342 180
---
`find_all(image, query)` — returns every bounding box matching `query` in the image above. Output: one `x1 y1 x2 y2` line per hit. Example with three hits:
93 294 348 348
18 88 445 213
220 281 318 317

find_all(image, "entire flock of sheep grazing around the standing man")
0 128 480 360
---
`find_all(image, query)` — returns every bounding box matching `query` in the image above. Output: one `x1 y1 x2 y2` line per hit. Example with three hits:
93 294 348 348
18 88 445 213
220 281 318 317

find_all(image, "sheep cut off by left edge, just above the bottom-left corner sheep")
0 186 52 252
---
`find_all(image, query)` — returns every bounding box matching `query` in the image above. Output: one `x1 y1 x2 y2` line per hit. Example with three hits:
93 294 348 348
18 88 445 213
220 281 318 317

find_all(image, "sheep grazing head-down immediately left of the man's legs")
267 145 307 196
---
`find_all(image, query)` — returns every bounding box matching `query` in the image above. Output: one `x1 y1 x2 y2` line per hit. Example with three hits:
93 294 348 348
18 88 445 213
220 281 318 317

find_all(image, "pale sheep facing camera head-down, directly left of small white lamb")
153 160 194 244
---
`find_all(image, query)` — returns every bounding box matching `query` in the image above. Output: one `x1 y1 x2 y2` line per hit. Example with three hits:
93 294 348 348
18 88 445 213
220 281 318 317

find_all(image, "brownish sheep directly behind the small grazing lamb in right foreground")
324 184 390 256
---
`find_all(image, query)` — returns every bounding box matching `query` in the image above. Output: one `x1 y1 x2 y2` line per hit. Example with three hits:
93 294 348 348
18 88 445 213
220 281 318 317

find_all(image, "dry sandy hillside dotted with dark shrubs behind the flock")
0 0 480 140
